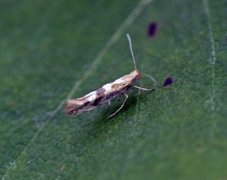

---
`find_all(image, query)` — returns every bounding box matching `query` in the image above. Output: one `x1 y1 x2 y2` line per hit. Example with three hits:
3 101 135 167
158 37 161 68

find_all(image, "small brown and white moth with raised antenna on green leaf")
64 34 153 118
